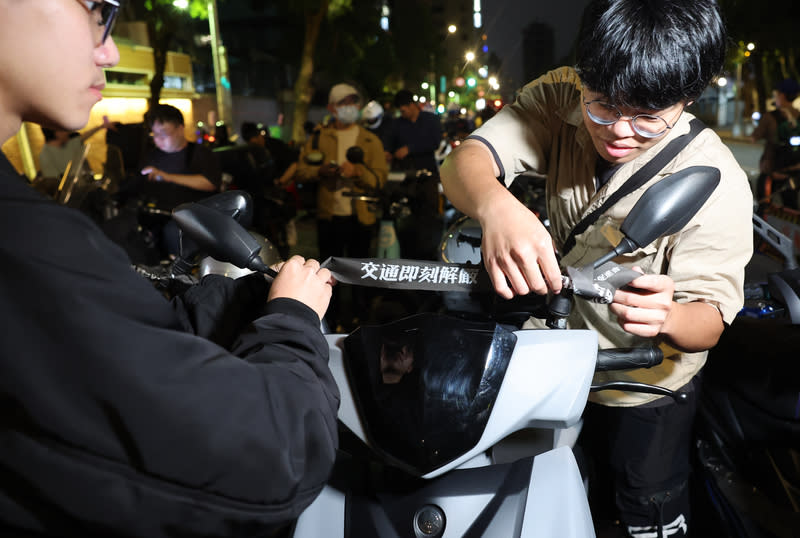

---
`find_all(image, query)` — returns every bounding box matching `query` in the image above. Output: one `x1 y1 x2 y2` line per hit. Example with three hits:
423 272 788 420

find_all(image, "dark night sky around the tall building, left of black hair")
482 0 588 91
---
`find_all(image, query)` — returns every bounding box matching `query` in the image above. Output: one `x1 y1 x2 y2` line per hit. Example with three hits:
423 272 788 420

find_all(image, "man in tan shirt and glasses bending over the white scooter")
441 0 752 537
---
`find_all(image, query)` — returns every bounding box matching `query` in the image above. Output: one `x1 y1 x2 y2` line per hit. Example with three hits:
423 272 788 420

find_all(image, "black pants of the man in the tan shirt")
579 383 697 538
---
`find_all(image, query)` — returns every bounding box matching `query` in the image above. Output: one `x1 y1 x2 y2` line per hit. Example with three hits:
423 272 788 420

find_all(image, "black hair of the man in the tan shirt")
575 0 727 110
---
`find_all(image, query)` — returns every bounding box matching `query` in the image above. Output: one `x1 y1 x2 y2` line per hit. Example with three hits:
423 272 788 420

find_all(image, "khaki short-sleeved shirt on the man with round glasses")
473 68 753 406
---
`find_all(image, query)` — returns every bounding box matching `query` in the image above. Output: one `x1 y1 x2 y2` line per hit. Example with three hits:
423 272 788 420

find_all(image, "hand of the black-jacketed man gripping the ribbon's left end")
267 256 334 320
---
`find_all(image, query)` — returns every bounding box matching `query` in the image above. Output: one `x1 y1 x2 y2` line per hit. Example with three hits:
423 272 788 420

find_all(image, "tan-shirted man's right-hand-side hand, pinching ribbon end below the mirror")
609 267 675 338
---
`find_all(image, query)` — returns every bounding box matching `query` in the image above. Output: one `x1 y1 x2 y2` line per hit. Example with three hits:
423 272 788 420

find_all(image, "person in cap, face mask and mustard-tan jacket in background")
296 83 389 329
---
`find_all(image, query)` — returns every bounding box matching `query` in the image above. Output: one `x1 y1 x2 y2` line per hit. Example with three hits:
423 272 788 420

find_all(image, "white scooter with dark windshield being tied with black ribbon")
176 167 719 538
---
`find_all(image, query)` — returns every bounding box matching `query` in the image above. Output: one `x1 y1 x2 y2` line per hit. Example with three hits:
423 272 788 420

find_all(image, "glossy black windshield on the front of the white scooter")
344 314 517 475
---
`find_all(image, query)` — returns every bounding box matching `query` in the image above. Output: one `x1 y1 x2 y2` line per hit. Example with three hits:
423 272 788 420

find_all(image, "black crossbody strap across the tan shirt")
561 118 706 257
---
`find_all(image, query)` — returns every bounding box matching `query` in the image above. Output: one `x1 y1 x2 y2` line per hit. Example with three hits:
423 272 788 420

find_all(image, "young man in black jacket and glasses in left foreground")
0 0 339 538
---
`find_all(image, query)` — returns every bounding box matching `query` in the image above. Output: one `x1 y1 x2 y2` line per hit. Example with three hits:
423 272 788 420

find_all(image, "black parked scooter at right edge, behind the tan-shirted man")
695 211 800 538
